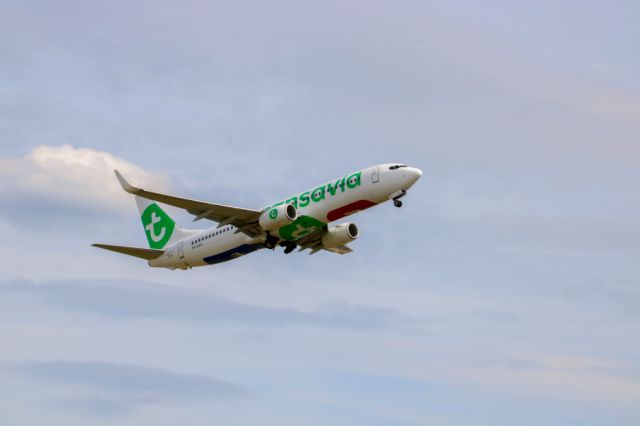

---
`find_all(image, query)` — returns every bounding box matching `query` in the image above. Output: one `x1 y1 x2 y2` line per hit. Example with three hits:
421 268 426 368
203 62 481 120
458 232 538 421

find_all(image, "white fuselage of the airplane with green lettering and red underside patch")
149 164 422 269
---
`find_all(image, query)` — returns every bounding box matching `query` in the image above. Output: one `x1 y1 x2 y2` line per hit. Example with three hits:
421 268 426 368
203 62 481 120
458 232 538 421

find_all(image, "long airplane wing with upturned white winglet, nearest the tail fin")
114 170 262 237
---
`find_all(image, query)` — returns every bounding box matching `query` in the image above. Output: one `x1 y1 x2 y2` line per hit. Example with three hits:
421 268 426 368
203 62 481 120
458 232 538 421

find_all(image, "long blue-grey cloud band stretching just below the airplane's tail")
0 281 413 330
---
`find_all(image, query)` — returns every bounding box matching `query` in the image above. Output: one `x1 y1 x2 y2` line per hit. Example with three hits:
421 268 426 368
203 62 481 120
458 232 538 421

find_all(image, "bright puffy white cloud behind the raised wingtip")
0 145 167 209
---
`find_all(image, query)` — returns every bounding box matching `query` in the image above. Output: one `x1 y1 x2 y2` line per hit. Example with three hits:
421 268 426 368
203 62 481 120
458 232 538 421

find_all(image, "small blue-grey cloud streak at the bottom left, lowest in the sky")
10 360 250 417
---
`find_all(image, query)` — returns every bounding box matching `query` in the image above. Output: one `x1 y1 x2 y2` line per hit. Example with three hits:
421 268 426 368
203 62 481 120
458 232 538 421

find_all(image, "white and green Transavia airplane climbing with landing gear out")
92 163 422 270
